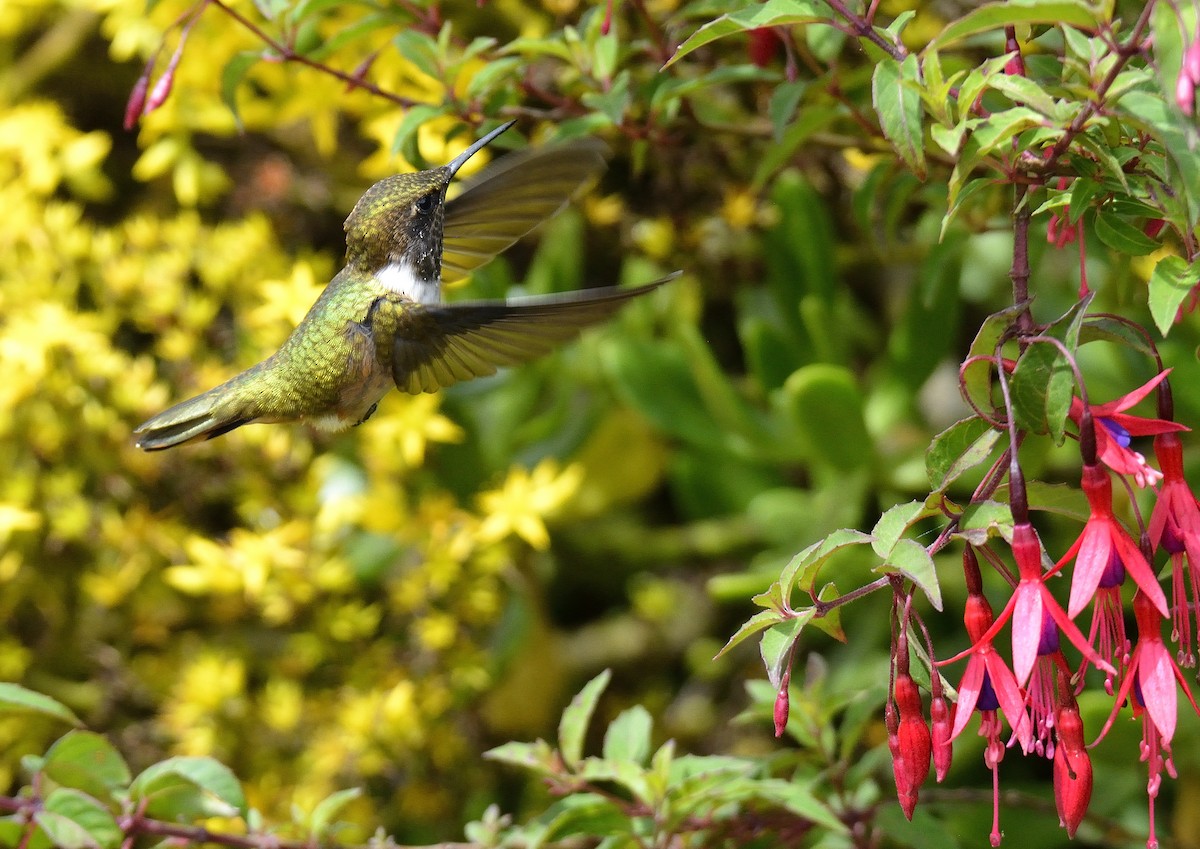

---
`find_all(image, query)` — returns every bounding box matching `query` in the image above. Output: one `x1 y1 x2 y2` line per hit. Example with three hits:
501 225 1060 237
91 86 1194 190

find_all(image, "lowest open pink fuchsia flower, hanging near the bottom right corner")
1093 592 1200 847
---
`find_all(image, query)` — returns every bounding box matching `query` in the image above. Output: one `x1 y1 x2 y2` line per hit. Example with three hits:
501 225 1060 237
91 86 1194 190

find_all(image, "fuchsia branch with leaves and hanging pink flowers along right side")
734 4 1200 849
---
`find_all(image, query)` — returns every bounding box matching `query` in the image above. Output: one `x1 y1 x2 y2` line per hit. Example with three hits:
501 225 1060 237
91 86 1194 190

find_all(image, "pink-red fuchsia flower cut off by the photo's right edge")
1150 433 1200 667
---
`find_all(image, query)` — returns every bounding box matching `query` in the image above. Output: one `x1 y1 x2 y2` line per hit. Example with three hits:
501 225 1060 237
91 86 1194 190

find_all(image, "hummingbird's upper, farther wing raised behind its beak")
442 139 608 283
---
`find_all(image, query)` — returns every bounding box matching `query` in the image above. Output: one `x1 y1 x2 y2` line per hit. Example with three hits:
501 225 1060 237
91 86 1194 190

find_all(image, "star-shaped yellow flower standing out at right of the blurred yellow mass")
479 459 583 549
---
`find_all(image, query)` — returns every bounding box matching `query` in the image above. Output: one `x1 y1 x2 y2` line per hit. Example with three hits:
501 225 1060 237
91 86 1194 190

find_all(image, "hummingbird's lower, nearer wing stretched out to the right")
391 271 679 395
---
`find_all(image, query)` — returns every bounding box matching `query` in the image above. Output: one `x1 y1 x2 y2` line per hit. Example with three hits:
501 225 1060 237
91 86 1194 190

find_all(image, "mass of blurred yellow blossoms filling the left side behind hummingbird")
0 0 667 837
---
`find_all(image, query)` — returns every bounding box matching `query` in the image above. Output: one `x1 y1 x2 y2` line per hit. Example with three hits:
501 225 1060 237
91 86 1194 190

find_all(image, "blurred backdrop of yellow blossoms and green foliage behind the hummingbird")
0 0 1200 845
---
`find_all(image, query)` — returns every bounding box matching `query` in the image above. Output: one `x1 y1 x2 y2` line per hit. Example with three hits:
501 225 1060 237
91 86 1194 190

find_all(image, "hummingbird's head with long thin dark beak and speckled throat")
344 121 516 285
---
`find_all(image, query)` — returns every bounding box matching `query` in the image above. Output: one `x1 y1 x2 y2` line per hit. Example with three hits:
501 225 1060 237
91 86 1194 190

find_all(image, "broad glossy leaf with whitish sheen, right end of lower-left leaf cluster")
130 757 246 820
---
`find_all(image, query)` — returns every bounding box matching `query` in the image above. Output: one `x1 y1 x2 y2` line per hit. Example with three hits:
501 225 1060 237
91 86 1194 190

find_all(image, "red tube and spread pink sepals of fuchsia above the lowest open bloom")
1055 465 1168 619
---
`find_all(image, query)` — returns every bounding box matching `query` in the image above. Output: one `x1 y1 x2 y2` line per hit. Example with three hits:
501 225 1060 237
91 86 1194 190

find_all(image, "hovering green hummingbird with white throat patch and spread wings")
134 121 678 451
